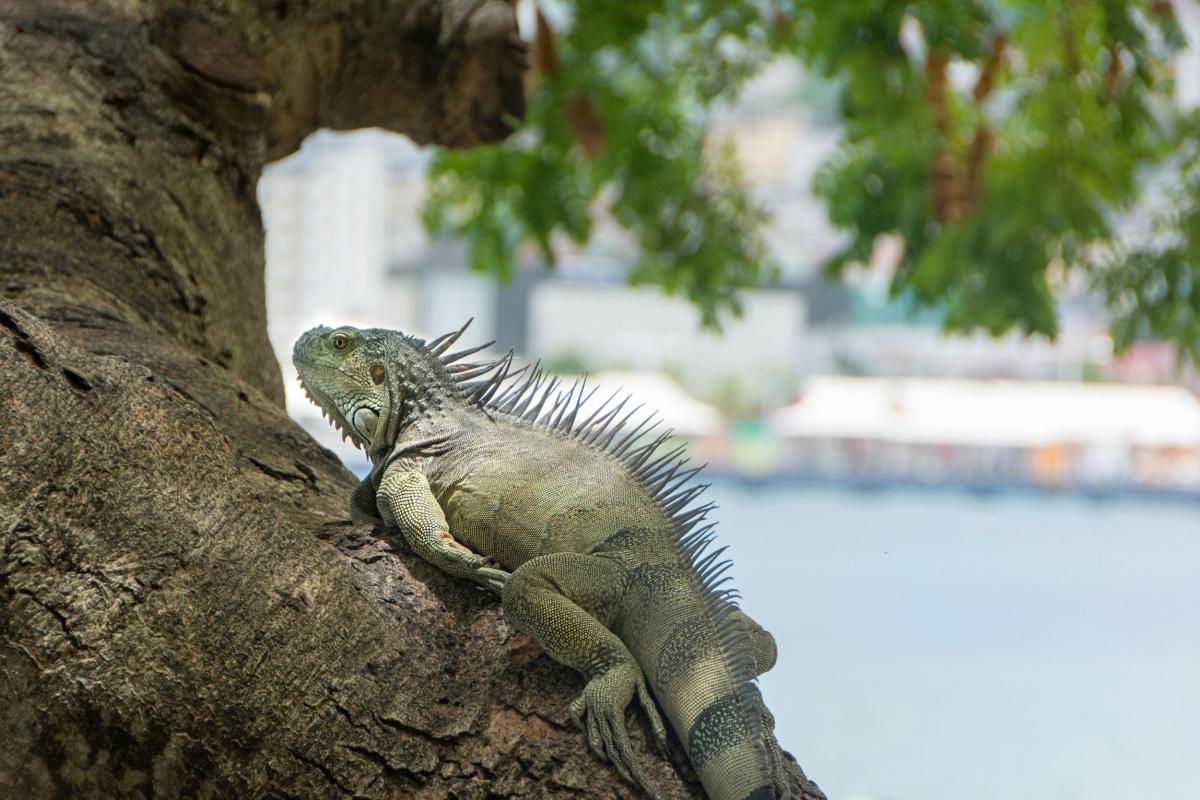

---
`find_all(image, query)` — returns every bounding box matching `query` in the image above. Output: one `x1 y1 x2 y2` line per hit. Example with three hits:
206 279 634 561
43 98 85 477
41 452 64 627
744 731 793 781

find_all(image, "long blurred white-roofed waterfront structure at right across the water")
768 375 1200 487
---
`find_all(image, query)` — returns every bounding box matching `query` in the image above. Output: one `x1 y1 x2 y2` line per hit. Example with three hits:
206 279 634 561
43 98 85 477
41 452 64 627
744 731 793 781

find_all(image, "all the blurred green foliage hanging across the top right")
427 0 1200 357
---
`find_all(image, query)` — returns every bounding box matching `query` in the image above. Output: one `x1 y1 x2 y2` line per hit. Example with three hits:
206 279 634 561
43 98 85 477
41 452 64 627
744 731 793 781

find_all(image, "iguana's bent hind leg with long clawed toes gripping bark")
504 553 666 798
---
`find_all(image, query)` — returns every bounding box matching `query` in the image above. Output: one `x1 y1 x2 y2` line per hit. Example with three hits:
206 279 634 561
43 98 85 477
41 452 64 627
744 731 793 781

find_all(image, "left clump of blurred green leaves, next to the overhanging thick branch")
426 0 774 324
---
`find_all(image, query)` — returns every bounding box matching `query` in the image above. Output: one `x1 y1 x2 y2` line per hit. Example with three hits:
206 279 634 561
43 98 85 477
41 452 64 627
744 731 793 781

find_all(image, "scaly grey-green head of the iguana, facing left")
292 320 501 455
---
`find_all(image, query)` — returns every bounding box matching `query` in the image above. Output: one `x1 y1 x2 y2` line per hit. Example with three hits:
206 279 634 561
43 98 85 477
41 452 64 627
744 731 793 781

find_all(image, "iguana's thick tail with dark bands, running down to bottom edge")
598 527 787 800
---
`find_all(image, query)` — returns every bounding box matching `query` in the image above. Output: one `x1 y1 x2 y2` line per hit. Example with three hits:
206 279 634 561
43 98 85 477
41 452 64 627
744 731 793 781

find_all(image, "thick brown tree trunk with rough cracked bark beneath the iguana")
0 0 817 798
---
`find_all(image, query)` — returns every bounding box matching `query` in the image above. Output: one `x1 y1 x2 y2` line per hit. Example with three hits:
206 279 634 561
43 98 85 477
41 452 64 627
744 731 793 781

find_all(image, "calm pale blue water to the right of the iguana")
706 482 1200 800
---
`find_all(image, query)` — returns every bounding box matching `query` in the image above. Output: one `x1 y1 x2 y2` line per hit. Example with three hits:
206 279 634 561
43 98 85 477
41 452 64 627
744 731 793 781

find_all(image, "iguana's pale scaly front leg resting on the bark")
376 462 511 593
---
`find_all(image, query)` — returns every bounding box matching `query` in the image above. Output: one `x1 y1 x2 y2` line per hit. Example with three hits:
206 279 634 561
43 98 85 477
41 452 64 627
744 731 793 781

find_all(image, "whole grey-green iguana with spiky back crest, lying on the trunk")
293 320 803 800
